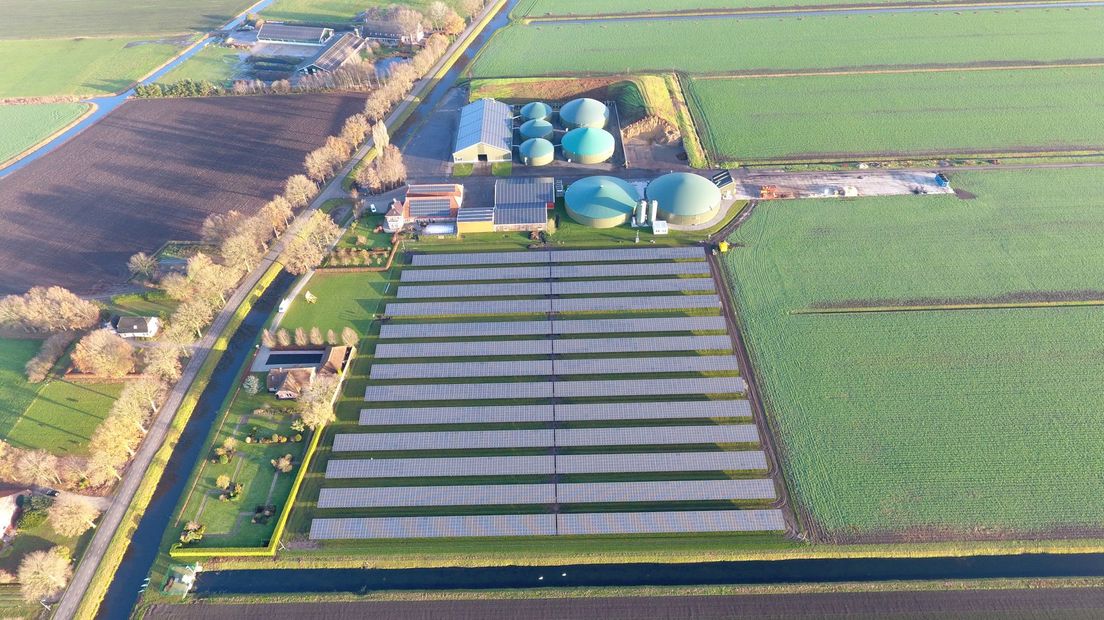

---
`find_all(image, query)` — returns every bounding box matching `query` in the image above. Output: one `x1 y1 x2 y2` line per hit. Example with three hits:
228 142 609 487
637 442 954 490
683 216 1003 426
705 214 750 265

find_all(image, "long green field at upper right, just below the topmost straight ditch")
469 9 1104 77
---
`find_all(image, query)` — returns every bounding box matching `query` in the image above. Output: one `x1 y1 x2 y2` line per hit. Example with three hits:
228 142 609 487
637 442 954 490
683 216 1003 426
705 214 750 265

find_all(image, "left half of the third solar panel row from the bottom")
326 452 552 480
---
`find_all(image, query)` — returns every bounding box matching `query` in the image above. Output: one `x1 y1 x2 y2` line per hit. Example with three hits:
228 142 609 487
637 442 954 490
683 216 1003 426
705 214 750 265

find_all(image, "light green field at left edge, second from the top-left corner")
0 39 187 97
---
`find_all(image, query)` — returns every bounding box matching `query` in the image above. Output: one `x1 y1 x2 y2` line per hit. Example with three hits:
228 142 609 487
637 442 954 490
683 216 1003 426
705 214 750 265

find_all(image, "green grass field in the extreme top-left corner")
0 0 254 39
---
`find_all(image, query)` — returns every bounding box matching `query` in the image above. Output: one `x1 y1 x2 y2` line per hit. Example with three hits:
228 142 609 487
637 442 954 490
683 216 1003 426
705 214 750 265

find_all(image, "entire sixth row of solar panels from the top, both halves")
374 335 732 360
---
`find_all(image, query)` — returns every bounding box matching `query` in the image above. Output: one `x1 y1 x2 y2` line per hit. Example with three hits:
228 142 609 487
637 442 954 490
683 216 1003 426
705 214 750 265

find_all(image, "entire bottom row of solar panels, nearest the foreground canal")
310 509 786 541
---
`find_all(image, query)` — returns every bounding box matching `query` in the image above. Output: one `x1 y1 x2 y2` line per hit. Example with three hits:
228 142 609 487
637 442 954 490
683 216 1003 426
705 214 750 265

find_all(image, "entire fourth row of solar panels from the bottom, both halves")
333 424 758 452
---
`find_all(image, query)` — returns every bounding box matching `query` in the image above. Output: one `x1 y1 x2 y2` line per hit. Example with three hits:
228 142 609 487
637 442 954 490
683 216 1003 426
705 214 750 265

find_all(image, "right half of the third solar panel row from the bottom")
560 450 766 478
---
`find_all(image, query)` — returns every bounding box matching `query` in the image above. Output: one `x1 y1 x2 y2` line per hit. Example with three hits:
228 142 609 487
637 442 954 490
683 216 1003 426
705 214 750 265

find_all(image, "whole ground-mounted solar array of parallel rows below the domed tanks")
310 247 785 539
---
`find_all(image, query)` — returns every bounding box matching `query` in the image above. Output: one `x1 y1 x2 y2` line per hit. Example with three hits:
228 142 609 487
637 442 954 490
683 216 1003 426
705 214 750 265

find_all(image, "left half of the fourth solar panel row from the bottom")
333 427 552 452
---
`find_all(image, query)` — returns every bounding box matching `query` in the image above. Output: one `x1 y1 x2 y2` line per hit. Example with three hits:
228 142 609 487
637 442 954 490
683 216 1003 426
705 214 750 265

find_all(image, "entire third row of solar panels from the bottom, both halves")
326 450 766 480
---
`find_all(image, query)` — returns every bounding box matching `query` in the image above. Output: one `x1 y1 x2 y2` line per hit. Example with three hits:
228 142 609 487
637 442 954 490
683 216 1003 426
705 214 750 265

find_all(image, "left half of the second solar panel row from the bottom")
318 484 555 509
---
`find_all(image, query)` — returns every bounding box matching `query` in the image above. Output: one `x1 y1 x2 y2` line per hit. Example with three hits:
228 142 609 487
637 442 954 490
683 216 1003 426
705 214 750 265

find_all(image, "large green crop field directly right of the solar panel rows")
726 170 1104 541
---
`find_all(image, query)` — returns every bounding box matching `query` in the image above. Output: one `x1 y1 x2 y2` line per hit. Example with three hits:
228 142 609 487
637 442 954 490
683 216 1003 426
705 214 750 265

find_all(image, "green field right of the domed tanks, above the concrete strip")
690 67 1104 162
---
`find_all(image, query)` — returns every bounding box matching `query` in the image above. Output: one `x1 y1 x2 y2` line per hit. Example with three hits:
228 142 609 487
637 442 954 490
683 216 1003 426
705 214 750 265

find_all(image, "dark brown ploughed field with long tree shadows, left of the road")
0 95 363 293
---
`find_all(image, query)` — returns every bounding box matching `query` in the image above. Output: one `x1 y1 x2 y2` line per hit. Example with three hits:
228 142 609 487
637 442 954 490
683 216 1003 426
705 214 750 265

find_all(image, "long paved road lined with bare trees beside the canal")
54 2 510 620
